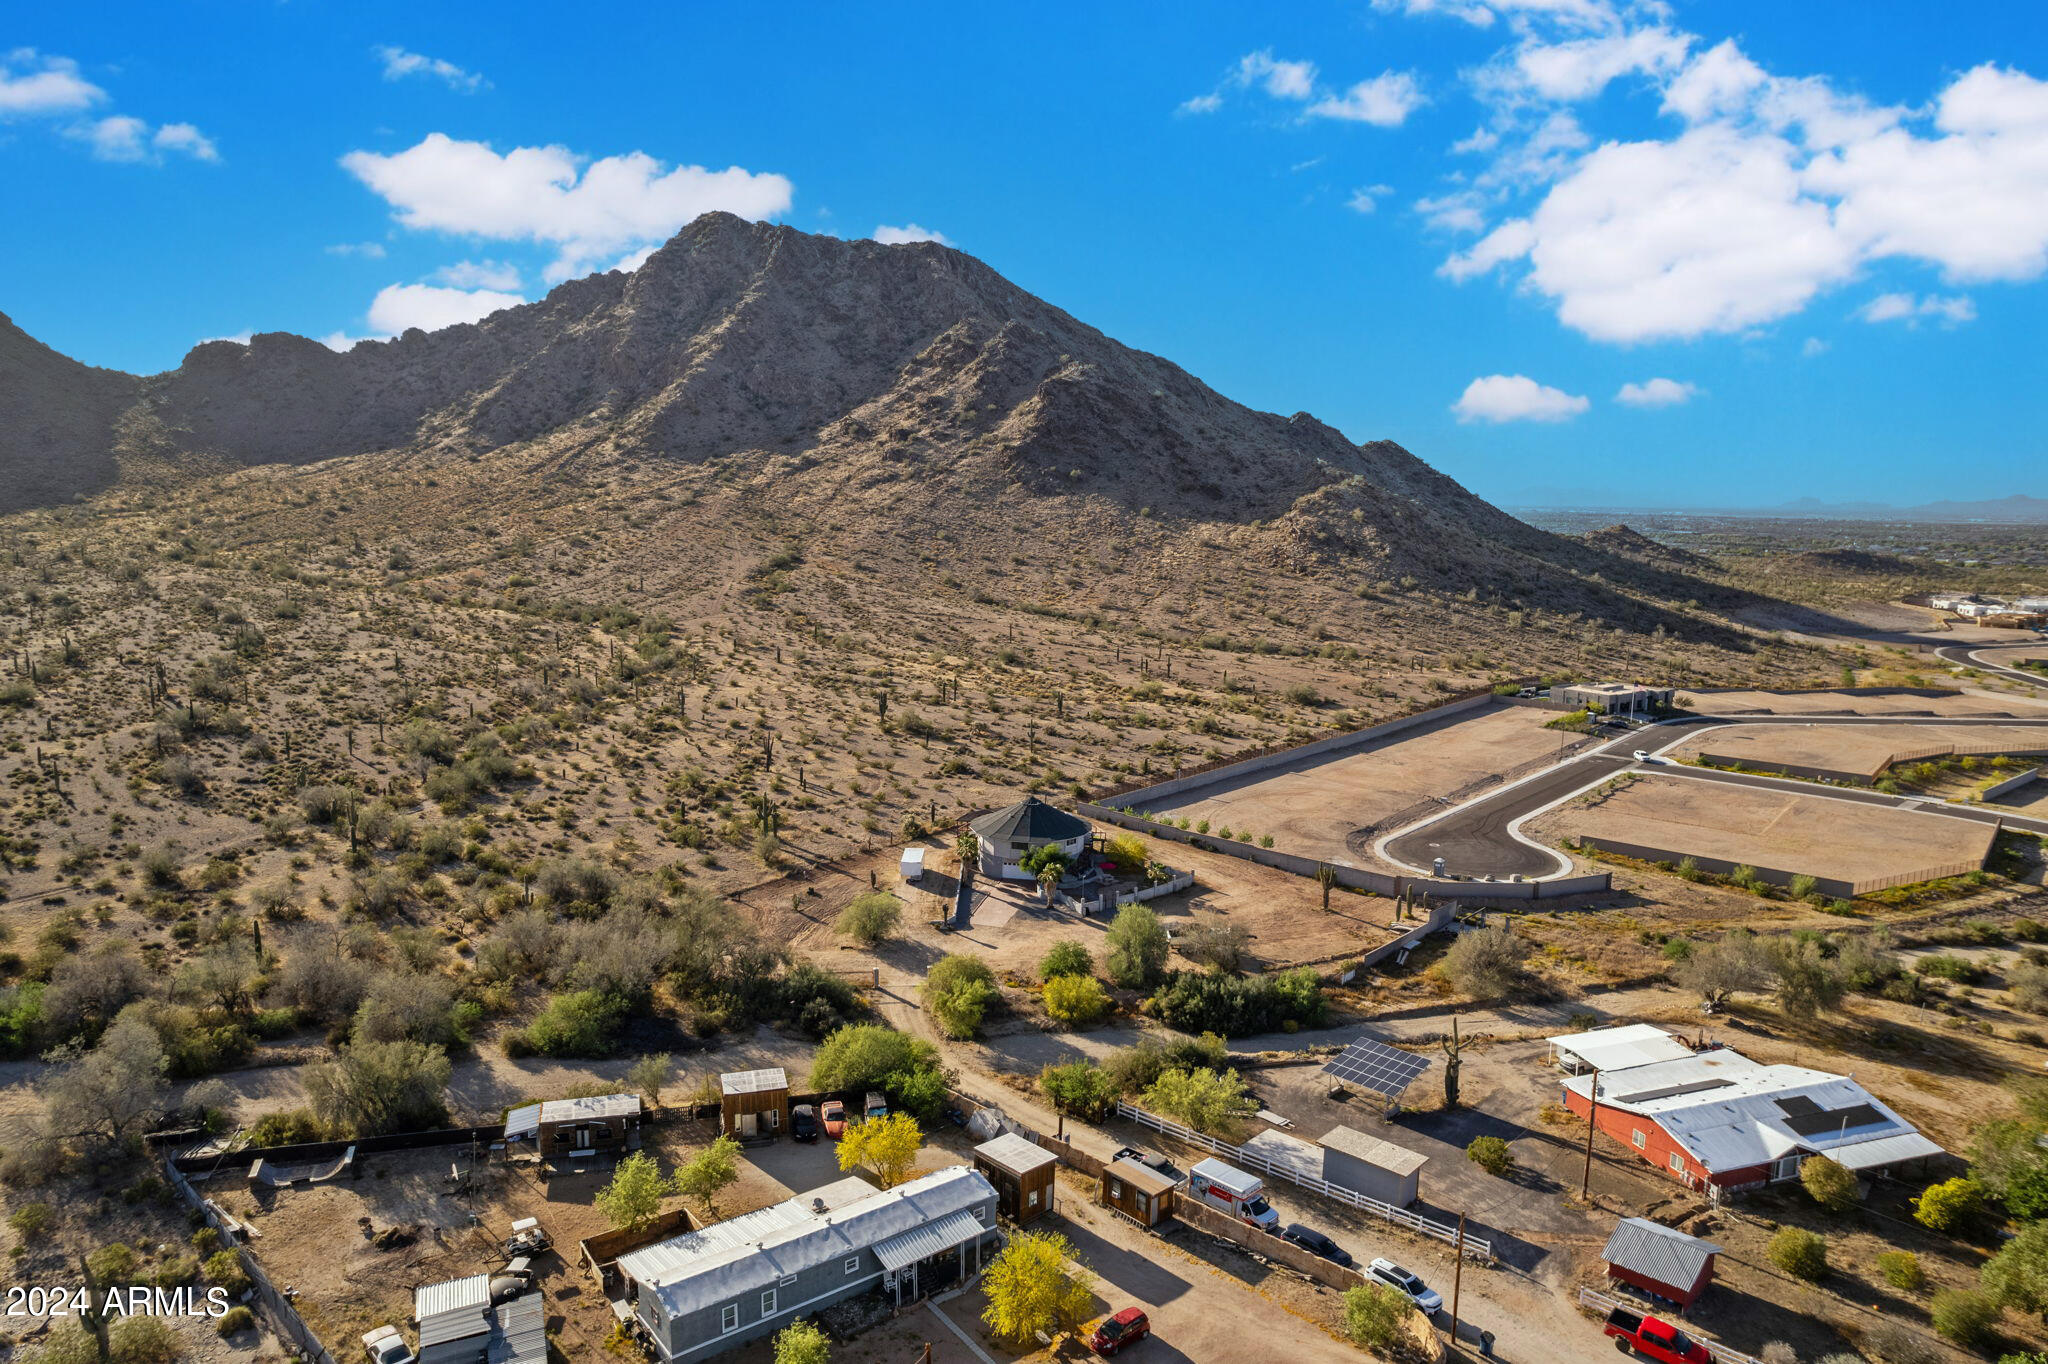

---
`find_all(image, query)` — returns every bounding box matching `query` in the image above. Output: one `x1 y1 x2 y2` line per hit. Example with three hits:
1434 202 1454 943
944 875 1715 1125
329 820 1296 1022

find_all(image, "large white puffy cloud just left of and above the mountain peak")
342 133 795 281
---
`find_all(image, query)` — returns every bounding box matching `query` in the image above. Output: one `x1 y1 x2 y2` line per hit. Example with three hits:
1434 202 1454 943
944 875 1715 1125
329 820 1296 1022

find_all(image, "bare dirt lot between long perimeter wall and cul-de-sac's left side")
1155 707 1569 860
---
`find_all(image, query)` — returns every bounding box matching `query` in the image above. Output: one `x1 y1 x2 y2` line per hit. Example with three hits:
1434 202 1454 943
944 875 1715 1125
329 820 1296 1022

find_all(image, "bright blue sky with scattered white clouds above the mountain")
0 0 2048 506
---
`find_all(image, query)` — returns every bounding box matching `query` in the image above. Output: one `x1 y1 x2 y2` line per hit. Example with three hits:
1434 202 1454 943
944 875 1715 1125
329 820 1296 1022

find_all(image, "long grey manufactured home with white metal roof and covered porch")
618 1165 999 1360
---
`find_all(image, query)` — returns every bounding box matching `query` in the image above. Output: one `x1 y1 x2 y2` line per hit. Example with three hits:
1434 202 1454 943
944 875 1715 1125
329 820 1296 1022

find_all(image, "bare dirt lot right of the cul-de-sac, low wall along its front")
1530 774 1995 883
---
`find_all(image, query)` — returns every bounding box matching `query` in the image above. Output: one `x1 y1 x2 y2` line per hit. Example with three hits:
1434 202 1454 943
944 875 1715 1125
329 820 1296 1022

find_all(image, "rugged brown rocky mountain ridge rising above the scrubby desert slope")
16 213 1688 600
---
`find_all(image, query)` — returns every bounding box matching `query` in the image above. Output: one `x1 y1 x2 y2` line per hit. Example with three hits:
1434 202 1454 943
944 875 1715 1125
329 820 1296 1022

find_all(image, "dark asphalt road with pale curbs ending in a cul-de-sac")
1380 704 2048 879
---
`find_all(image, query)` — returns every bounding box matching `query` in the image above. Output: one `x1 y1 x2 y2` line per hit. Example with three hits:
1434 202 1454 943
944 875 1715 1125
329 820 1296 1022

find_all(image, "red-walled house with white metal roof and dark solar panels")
1565 1049 1942 1198
